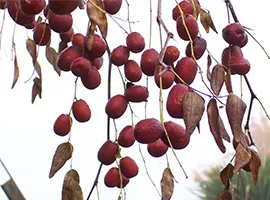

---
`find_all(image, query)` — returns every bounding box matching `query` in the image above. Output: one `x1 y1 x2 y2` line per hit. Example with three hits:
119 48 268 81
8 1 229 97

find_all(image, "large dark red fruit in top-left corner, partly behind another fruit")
7 0 35 26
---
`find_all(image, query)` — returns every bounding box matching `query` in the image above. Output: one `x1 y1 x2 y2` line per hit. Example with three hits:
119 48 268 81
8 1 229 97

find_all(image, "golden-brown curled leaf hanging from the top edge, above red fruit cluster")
87 0 108 38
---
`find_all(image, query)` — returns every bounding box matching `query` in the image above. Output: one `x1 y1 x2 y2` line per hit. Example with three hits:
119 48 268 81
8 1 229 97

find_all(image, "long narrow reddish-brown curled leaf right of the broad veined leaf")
207 99 226 153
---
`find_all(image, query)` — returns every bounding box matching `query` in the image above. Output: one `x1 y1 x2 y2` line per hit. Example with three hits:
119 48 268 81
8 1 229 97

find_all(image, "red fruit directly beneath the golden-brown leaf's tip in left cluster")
85 34 107 59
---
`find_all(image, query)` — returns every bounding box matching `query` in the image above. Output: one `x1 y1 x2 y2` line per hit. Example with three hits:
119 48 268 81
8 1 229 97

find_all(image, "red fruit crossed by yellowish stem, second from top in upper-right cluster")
176 14 199 41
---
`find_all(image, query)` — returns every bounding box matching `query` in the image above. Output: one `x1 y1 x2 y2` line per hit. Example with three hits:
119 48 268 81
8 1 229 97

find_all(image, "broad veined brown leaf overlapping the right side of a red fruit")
183 92 205 136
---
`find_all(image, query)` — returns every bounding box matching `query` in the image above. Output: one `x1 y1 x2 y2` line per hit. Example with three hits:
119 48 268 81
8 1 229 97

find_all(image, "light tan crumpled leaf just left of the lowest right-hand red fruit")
233 143 251 173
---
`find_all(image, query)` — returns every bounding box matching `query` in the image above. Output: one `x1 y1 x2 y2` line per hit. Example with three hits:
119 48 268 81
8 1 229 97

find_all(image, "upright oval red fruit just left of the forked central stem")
141 49 159 76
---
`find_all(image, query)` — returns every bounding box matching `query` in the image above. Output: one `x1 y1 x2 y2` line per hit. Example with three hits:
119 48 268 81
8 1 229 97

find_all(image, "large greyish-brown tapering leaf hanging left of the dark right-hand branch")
226 93 247 143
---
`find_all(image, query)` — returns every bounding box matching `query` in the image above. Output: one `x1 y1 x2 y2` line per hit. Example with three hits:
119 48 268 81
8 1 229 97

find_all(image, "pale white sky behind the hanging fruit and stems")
0 0 270 200
